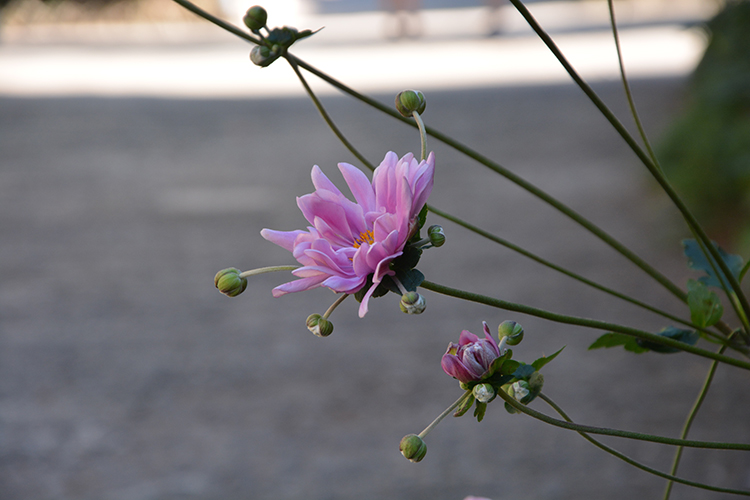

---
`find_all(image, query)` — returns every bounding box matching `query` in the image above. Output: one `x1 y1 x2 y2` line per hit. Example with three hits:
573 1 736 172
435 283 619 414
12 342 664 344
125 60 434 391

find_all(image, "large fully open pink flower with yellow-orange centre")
260 152 435 317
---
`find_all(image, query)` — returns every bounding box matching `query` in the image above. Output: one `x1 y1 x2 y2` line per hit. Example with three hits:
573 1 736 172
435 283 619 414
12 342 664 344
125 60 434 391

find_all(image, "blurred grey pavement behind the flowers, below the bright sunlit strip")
0 0 750 500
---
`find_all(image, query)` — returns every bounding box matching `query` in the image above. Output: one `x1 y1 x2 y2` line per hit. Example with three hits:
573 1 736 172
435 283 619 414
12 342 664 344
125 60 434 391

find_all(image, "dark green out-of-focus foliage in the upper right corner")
658 1 750 247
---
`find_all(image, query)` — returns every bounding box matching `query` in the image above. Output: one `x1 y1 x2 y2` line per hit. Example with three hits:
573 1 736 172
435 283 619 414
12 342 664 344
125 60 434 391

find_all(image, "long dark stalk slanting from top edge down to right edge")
510 0 750 317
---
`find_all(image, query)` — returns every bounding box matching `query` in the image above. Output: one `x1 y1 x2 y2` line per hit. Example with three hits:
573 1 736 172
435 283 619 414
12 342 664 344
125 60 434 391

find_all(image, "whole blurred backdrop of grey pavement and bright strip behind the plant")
0 0 750 500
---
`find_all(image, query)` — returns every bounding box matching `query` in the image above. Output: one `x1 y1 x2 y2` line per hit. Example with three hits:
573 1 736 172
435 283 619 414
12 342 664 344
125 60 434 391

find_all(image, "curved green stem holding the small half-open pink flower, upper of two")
497 391 750 451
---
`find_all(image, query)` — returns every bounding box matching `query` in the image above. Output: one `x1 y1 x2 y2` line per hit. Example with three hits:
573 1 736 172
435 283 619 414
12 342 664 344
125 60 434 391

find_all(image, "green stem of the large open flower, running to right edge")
420 280 750 372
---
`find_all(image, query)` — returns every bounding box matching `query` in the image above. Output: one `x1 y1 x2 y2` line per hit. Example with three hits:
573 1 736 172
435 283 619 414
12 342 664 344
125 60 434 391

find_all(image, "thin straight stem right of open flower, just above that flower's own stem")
427 205 725 341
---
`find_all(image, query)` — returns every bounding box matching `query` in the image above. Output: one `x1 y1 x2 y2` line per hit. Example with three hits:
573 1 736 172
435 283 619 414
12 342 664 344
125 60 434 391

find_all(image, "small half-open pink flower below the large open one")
440 321 504 383
